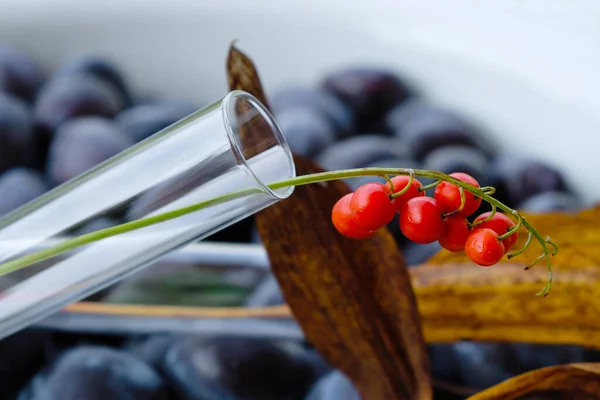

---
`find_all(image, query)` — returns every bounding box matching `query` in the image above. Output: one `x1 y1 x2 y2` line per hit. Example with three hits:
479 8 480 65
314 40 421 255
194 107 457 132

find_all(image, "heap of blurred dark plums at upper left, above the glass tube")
0 43 200 231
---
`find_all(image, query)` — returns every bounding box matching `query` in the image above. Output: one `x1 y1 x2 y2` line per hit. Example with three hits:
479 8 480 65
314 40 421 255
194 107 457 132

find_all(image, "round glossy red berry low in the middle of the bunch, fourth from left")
400 197 446 244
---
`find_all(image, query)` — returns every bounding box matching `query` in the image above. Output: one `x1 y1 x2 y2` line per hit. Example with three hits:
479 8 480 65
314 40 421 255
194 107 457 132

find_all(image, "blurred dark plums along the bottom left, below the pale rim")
5 325 331 400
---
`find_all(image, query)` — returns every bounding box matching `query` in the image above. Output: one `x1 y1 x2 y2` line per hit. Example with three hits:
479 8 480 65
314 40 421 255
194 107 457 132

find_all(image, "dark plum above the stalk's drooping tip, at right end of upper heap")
488 153 570 206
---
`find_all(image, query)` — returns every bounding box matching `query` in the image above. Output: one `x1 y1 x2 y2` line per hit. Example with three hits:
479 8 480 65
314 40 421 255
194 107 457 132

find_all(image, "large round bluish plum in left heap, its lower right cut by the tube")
48 117 133 184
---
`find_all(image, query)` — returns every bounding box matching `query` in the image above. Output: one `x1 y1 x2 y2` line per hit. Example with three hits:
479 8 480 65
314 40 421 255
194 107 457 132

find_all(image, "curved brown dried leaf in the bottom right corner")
468 363 600 400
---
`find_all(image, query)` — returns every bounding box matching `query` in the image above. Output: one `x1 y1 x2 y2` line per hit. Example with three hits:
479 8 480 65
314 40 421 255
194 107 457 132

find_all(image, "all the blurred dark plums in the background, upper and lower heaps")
0 45 584 400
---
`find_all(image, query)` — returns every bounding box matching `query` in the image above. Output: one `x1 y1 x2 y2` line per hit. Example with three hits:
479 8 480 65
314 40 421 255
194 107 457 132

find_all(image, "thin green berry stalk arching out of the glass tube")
0 168 558 296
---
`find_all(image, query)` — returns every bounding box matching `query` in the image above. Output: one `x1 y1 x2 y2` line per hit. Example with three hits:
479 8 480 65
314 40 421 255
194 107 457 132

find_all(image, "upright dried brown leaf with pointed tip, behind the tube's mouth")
228 46 432 400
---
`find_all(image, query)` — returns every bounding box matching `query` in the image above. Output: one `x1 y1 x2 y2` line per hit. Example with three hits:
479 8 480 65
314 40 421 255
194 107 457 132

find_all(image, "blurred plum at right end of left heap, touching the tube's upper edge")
115 101 198 142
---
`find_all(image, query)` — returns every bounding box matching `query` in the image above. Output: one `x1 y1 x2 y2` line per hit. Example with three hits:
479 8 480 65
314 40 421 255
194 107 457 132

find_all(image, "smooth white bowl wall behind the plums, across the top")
0 0 600 202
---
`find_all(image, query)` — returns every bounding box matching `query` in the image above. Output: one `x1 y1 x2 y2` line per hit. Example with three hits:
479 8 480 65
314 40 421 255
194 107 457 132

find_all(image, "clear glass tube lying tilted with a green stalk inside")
0 91 295 337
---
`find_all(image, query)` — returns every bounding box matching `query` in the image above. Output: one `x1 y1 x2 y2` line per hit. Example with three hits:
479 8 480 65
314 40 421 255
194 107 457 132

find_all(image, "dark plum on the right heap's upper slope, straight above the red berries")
386 101 494 160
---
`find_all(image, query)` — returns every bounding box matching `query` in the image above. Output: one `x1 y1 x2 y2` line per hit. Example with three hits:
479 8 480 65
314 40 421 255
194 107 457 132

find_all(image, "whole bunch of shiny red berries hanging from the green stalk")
331 172 518 267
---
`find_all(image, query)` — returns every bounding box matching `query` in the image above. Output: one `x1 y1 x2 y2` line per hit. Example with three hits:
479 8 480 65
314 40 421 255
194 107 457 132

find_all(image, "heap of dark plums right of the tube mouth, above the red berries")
271 68 581 265
